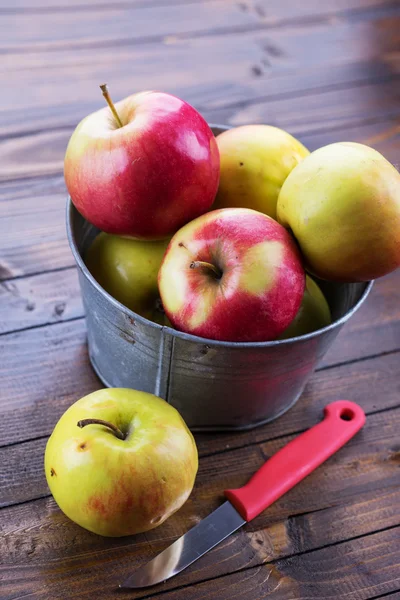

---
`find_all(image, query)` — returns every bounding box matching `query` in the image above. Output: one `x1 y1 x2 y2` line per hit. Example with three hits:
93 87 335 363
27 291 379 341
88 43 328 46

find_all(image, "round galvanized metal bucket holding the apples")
67 126 372 431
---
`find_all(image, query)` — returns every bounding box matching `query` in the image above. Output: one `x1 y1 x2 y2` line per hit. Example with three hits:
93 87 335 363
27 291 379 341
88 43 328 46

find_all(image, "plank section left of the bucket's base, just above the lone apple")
0 320 102 443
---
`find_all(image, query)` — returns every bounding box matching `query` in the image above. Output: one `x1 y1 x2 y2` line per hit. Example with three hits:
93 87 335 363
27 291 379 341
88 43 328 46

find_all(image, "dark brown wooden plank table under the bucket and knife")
0 0 400 600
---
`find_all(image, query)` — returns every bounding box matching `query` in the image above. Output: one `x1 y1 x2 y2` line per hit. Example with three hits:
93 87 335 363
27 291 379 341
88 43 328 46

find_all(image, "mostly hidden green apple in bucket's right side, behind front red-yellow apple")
278 275 332 340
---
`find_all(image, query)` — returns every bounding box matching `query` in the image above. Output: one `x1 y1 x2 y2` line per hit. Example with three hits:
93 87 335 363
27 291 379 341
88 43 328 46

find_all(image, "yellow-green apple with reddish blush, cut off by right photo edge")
277 142 400 282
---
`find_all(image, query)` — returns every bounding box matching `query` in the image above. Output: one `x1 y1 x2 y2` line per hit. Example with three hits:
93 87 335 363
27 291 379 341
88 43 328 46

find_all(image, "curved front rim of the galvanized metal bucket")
66 196 374 348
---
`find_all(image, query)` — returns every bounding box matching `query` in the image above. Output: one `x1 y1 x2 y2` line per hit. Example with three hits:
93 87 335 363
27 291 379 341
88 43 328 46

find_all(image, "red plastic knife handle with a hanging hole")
225 400 365 521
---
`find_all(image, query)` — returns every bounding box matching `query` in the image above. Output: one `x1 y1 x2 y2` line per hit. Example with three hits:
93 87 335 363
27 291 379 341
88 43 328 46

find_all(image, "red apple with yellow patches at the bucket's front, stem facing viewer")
158 208 305 342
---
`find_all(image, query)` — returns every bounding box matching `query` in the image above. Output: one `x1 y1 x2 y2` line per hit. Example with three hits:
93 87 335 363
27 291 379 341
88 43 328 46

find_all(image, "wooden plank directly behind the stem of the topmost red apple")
0 14 400 136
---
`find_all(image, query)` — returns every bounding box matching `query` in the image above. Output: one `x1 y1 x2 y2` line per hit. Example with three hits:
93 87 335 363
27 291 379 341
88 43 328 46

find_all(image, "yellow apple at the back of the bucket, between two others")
212 125 310 219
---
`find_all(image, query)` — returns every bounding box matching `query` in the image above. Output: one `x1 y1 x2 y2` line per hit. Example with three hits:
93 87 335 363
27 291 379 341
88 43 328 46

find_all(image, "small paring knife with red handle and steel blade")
120 400 365 589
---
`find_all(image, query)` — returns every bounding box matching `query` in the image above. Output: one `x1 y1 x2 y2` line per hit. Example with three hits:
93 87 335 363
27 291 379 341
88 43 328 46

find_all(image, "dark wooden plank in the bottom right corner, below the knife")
145 528 400 600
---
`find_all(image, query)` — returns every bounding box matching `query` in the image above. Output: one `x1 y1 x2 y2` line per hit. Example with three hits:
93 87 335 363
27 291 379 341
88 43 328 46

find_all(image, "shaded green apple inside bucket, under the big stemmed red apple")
85 233 170 325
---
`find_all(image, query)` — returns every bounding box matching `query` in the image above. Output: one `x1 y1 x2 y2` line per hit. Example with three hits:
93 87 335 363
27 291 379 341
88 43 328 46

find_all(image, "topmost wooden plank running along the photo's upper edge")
0 0 396 53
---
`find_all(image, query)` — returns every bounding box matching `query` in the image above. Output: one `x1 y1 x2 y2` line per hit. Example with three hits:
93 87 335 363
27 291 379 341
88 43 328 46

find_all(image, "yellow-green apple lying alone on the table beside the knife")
44 388 198 536
